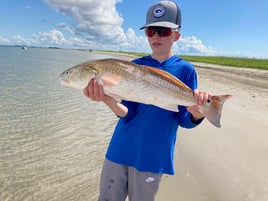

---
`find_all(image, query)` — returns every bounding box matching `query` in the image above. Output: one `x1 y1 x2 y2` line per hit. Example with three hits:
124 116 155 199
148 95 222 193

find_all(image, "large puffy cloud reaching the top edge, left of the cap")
46 0 124 41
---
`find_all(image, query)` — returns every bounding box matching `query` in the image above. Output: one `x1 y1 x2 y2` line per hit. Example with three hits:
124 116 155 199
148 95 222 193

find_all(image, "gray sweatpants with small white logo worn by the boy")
99 159 161 201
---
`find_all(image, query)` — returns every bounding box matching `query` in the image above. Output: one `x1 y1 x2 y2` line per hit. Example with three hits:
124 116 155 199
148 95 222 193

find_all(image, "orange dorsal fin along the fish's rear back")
143 66 192 92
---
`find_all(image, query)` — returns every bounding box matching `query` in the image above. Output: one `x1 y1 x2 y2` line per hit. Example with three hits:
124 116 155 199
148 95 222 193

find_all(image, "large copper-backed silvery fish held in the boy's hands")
59 59 231 127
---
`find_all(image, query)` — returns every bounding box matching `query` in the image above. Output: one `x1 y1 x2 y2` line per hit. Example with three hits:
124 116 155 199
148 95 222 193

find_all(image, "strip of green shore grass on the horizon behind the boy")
94 51 268 70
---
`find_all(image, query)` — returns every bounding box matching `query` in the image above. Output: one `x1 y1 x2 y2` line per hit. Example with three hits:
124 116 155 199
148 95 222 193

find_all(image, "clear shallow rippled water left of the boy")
0 47 117 201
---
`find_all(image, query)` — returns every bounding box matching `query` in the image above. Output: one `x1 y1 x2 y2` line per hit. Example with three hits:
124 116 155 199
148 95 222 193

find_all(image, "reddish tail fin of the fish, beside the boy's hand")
202 95 232 128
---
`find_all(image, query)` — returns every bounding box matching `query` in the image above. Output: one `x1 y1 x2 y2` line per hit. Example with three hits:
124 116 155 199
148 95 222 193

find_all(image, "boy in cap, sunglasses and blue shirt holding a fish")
84 1 211 201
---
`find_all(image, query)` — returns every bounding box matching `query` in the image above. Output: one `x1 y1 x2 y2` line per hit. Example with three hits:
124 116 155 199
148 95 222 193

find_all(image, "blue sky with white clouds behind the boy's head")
0 0 268 58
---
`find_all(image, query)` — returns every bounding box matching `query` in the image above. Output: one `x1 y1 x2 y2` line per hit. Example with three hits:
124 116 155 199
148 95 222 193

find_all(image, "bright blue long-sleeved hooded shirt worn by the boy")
106 56 201 175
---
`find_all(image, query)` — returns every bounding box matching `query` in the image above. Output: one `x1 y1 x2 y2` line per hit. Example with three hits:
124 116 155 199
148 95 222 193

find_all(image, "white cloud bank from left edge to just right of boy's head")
0 0 218 54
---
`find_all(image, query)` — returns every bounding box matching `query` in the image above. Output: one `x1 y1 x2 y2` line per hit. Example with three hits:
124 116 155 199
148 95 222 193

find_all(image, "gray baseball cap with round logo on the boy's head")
140 0 181 29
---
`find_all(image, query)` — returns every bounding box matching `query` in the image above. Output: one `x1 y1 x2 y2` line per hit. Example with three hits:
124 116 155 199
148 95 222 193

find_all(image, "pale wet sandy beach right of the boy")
156 63 268 201
